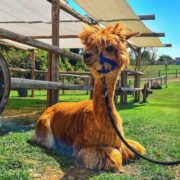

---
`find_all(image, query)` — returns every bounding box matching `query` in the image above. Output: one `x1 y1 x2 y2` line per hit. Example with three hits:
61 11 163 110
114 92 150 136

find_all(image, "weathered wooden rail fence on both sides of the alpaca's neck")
9 67 156 103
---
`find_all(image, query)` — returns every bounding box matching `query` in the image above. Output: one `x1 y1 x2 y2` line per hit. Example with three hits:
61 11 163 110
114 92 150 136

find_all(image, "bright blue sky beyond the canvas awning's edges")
69 0 180 58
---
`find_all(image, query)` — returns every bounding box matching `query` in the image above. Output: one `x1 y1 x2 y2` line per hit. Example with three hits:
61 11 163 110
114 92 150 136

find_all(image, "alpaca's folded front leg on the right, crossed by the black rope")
120 139 146 161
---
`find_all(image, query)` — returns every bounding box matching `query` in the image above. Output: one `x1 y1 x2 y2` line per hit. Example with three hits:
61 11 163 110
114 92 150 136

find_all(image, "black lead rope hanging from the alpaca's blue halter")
102 76 180 166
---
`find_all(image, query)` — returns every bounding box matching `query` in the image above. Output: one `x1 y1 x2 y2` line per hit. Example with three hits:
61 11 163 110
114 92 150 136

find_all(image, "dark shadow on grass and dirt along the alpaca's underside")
28 140 139 180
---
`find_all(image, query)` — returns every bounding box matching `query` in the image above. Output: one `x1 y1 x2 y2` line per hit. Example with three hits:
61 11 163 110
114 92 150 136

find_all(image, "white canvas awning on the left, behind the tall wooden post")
0 0 85 49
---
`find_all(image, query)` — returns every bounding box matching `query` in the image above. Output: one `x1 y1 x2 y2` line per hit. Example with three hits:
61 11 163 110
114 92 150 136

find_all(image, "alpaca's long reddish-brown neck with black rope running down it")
93 73 118 126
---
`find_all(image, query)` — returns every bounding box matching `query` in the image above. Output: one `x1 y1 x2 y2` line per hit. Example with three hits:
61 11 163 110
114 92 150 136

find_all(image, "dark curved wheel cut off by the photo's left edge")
0 54 11 114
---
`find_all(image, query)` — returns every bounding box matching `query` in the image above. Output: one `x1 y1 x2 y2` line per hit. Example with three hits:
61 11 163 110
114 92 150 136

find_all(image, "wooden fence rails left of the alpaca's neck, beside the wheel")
9 67 93 95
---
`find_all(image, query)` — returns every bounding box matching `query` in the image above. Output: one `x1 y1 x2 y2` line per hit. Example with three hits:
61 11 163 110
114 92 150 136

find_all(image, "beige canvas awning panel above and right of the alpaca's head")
75 0 164 47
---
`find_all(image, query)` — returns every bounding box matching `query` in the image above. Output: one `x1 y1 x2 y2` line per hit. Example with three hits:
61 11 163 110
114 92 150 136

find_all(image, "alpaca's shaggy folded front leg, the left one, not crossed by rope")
77 147 122 171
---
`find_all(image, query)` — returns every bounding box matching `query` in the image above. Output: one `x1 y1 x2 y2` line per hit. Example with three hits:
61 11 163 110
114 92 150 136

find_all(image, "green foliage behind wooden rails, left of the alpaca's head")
0 46 87 71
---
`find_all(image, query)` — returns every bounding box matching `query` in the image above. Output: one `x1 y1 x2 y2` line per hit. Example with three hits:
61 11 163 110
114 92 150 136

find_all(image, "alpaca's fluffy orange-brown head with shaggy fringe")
79 23 138 78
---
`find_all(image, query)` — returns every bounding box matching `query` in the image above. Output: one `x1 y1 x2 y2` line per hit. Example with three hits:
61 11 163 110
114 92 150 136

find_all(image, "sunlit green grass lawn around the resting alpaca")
0 81 180 180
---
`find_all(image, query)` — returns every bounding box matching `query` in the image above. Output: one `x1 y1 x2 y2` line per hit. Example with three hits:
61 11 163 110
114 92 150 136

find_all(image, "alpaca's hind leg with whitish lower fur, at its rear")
32 118 55 149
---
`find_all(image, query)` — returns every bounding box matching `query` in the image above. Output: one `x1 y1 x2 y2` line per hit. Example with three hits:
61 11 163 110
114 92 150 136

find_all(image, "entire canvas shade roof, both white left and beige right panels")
0 0 167 49
